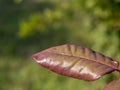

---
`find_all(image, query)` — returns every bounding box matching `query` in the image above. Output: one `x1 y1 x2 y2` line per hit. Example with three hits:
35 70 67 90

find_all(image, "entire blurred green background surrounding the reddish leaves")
0 0 120 90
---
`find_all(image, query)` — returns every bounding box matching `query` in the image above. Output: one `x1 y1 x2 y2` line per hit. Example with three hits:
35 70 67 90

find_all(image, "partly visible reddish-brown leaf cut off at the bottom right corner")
104 79 120 90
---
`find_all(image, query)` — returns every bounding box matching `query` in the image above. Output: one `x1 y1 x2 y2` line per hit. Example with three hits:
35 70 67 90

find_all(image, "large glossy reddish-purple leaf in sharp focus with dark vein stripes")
33 44 119 81
